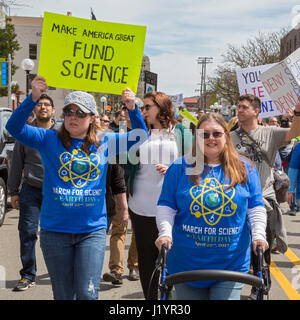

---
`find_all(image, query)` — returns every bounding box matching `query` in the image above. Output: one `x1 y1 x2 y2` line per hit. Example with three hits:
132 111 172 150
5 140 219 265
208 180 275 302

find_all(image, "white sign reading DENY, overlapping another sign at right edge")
261 49 300 114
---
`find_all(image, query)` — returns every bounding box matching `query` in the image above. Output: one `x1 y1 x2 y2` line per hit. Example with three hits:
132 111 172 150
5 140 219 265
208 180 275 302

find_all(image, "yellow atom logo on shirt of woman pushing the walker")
190 178 237 226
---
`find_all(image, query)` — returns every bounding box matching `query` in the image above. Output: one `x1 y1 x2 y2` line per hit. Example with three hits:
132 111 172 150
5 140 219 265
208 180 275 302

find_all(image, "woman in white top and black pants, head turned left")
128 91 192 299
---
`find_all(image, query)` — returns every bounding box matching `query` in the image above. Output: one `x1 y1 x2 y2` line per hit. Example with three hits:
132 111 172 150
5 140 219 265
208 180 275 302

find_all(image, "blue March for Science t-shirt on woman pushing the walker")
158 158 264 287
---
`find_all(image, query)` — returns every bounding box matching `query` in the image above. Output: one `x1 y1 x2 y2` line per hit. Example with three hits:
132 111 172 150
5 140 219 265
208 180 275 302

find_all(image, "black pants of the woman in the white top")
129 209 159 300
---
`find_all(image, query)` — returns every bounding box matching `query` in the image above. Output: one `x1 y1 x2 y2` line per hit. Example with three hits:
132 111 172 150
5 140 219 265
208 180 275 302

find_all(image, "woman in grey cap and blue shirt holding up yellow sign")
6 76 148 300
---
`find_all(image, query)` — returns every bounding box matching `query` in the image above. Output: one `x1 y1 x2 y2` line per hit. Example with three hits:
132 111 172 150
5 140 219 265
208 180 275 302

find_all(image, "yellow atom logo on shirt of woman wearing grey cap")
58 149 100 188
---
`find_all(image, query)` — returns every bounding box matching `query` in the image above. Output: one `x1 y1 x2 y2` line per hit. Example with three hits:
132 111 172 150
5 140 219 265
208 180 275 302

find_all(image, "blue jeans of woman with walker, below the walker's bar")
174 281 244 300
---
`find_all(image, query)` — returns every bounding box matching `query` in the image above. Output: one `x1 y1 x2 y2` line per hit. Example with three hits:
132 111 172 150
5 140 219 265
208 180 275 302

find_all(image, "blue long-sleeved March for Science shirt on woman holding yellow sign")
6 95 148 233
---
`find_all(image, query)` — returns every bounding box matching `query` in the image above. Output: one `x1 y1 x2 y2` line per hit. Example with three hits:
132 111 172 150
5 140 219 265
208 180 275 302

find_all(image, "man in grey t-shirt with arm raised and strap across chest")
231 94 300 298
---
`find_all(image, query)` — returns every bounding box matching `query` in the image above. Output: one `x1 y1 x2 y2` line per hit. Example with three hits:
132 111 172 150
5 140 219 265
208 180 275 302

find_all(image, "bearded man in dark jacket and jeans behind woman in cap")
8 94 55 291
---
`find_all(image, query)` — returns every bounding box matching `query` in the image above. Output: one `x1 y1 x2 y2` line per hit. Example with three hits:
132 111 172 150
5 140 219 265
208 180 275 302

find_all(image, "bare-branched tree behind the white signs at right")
208 28 288 104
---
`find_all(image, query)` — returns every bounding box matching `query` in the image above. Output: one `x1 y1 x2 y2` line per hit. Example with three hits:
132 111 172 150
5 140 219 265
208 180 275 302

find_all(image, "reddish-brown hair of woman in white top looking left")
144 91 176 128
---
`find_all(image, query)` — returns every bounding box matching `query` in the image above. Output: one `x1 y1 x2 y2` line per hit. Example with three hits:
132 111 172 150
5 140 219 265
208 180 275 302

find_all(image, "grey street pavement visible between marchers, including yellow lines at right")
0 204 300 301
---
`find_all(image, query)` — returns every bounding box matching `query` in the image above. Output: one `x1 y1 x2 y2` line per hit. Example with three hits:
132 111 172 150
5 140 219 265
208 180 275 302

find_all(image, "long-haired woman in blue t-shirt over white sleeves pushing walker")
156 113 268 300
